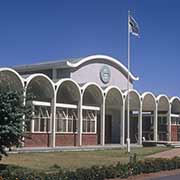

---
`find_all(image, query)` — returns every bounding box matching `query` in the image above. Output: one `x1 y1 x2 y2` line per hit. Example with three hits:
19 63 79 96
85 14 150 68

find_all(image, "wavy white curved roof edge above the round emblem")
67 55 139 81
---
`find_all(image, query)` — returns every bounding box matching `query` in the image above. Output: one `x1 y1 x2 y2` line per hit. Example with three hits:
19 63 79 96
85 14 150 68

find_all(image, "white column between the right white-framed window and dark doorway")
100 97 105 146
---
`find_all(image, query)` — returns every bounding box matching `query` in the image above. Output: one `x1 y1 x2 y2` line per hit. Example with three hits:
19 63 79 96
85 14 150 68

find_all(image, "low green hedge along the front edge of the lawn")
0 157 180 180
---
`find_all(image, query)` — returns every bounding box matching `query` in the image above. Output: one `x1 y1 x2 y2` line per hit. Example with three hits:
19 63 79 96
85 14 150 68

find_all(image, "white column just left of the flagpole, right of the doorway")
120 100 125 146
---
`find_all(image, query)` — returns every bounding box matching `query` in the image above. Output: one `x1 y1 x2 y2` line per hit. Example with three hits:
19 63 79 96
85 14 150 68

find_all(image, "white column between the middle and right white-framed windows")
78 94 83 146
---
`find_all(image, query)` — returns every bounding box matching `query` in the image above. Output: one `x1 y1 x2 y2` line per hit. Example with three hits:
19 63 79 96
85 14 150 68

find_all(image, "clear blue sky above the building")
0 0 180 96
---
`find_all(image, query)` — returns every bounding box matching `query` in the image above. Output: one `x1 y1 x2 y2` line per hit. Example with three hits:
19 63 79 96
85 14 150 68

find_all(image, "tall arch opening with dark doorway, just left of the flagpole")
104 86 123 144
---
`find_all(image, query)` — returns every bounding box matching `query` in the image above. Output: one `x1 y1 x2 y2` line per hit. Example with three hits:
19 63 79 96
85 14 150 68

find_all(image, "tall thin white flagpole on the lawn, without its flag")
127 11 131 152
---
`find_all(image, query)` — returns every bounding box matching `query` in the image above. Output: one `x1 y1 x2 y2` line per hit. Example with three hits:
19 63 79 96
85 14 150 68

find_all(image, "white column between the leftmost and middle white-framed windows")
51 92 56 147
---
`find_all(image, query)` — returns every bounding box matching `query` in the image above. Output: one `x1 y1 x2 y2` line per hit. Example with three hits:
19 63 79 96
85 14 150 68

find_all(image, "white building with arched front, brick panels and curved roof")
0 55 180 147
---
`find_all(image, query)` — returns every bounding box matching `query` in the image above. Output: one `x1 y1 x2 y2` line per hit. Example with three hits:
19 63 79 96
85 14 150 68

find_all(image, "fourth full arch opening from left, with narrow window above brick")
82 83 103 145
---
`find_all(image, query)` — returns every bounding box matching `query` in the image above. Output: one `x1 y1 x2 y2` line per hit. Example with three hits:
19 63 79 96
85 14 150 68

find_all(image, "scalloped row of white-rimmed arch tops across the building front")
0 68 180 107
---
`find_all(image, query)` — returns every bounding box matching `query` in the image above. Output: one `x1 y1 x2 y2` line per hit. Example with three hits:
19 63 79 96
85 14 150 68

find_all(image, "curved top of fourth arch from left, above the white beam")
81 82 104 106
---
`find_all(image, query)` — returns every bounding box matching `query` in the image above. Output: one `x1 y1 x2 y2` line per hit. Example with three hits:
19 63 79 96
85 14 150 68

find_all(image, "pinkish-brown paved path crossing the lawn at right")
147 148 180 159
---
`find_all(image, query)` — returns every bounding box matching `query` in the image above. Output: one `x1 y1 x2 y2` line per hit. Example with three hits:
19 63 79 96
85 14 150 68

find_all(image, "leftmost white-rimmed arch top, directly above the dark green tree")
0 68 24 91
